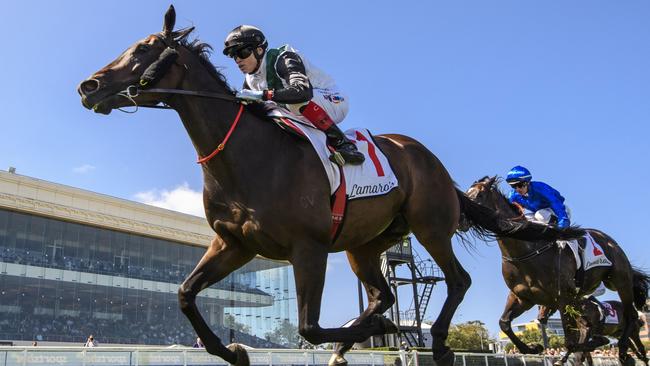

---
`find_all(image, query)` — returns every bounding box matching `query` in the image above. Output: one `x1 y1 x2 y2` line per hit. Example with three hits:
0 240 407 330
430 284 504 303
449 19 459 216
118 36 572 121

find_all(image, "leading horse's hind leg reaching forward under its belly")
334 240 398 364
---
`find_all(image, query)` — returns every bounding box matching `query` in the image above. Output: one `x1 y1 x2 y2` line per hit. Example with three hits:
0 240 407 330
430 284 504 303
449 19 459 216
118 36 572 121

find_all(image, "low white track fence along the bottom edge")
0 347 628 366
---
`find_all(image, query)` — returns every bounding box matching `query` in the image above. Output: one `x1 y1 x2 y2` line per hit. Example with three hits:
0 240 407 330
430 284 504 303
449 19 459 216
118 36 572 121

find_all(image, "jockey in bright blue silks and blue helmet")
506 165 570 228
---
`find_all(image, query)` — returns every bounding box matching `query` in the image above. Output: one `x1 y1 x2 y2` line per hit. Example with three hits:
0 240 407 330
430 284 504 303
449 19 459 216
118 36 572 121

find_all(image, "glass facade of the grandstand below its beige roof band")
0 209 296 347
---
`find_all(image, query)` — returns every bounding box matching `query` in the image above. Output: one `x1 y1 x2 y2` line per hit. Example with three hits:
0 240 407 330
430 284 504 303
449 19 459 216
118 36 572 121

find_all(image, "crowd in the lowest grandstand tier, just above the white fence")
0 315 284 348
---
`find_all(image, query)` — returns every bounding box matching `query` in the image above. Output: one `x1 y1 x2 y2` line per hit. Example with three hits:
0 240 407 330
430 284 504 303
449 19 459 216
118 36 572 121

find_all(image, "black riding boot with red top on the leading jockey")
300 101 366 166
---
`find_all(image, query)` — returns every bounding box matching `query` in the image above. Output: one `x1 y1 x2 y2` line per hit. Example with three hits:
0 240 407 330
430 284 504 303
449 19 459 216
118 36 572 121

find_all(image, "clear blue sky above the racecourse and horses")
0 0 650 333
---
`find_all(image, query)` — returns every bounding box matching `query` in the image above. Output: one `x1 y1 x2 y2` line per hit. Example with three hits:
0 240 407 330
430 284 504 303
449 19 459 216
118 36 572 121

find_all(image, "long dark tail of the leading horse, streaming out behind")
456 189 584 241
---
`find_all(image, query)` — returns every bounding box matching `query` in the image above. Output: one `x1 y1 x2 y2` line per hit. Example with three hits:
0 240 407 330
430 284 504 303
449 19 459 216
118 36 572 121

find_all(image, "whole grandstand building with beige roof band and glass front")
0 171 297 347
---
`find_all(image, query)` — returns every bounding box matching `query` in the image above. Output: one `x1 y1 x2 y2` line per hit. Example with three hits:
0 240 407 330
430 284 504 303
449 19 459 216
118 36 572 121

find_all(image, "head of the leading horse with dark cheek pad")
77 6 194 114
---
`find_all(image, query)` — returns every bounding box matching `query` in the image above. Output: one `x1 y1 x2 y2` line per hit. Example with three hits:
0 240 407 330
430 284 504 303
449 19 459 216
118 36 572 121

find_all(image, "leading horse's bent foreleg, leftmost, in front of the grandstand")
178 236 255 365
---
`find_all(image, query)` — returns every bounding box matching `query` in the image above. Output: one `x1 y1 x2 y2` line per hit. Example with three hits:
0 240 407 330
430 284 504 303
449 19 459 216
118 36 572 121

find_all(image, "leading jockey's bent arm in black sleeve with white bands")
264 51 314 104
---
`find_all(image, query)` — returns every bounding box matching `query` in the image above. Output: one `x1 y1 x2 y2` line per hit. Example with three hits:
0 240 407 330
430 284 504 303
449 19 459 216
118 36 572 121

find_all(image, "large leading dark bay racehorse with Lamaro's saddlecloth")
78 7 575 366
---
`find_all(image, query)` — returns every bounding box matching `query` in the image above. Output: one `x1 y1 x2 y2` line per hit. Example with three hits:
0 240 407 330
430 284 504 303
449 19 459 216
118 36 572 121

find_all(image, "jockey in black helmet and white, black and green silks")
223 25 365 165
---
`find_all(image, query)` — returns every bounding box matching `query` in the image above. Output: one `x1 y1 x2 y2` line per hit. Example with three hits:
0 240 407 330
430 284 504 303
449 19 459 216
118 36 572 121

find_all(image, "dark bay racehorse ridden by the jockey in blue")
467 177 649 363
